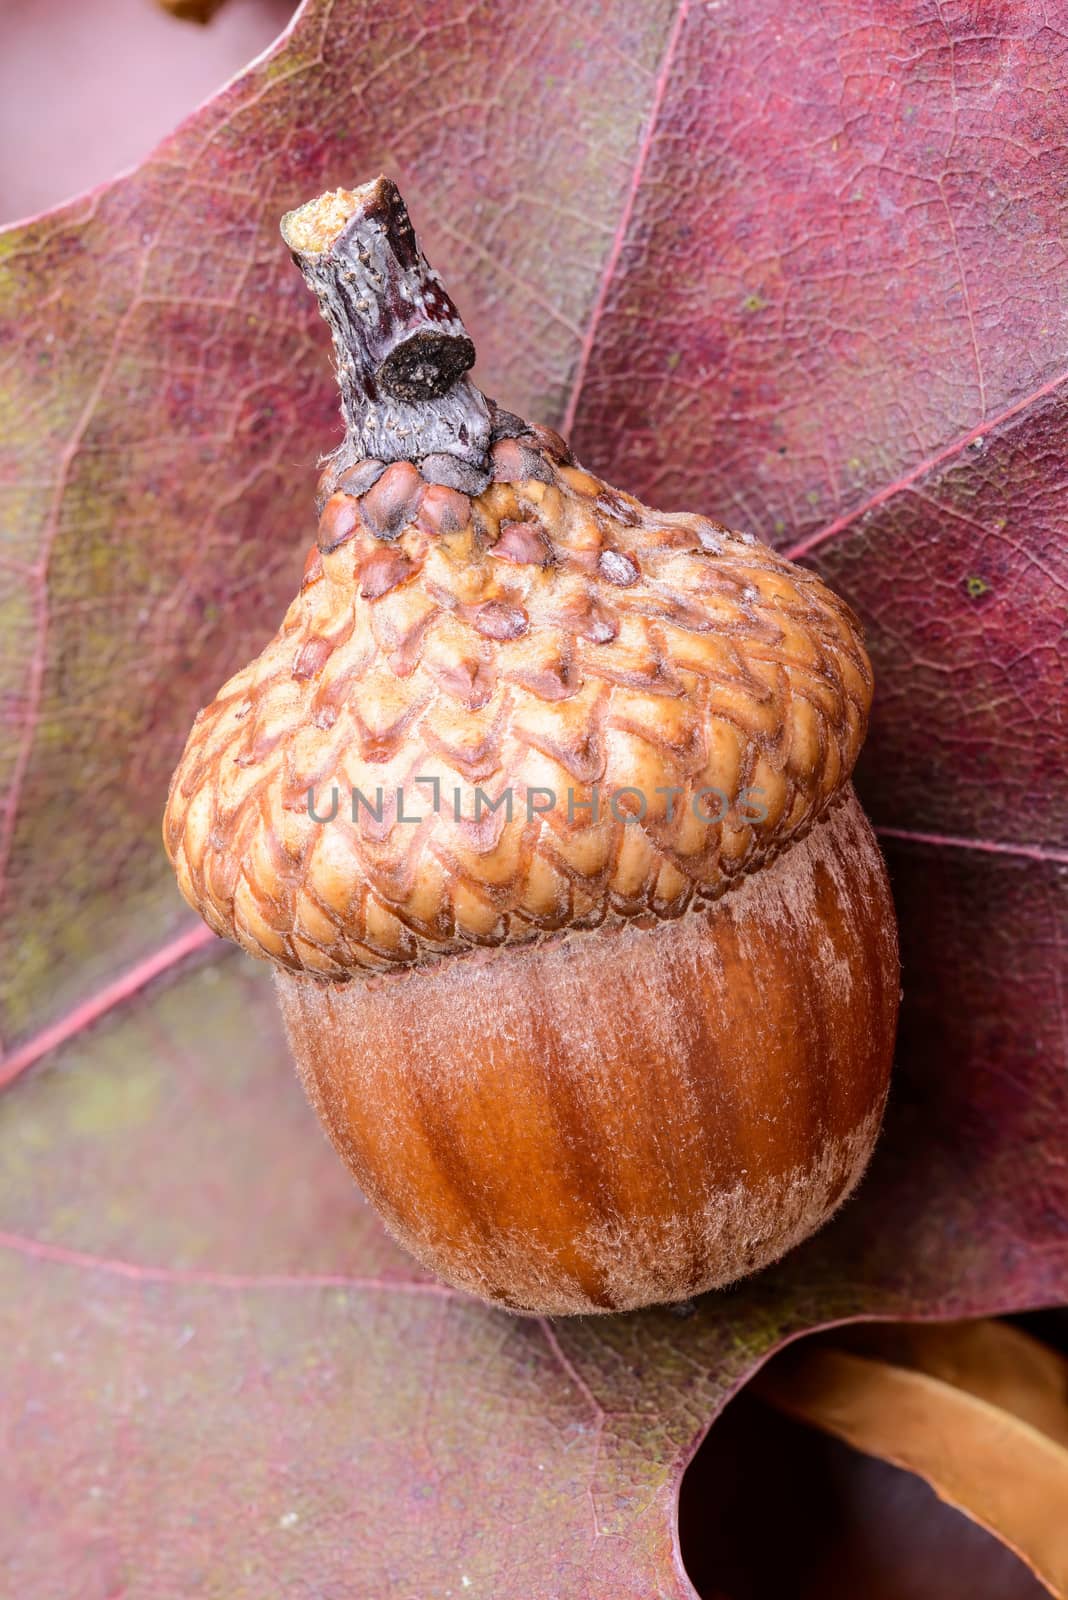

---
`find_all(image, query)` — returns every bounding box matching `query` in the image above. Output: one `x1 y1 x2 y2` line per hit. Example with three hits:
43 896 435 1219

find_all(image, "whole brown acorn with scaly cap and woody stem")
165 178 899 1314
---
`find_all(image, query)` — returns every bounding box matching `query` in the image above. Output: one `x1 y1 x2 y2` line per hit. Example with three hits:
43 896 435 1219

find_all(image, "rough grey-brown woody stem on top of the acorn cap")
281 178 491 474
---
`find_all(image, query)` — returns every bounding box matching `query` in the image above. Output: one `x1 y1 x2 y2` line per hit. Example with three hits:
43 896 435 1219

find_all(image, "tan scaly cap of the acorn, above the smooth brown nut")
165 179 871 979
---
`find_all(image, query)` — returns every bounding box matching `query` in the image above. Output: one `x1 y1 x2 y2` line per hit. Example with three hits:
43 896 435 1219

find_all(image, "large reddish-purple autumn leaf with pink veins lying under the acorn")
0 0 1068 1600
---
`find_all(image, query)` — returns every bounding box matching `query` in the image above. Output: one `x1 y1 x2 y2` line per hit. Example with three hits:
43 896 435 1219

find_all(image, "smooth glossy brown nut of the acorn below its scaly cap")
277 789 899 1314
